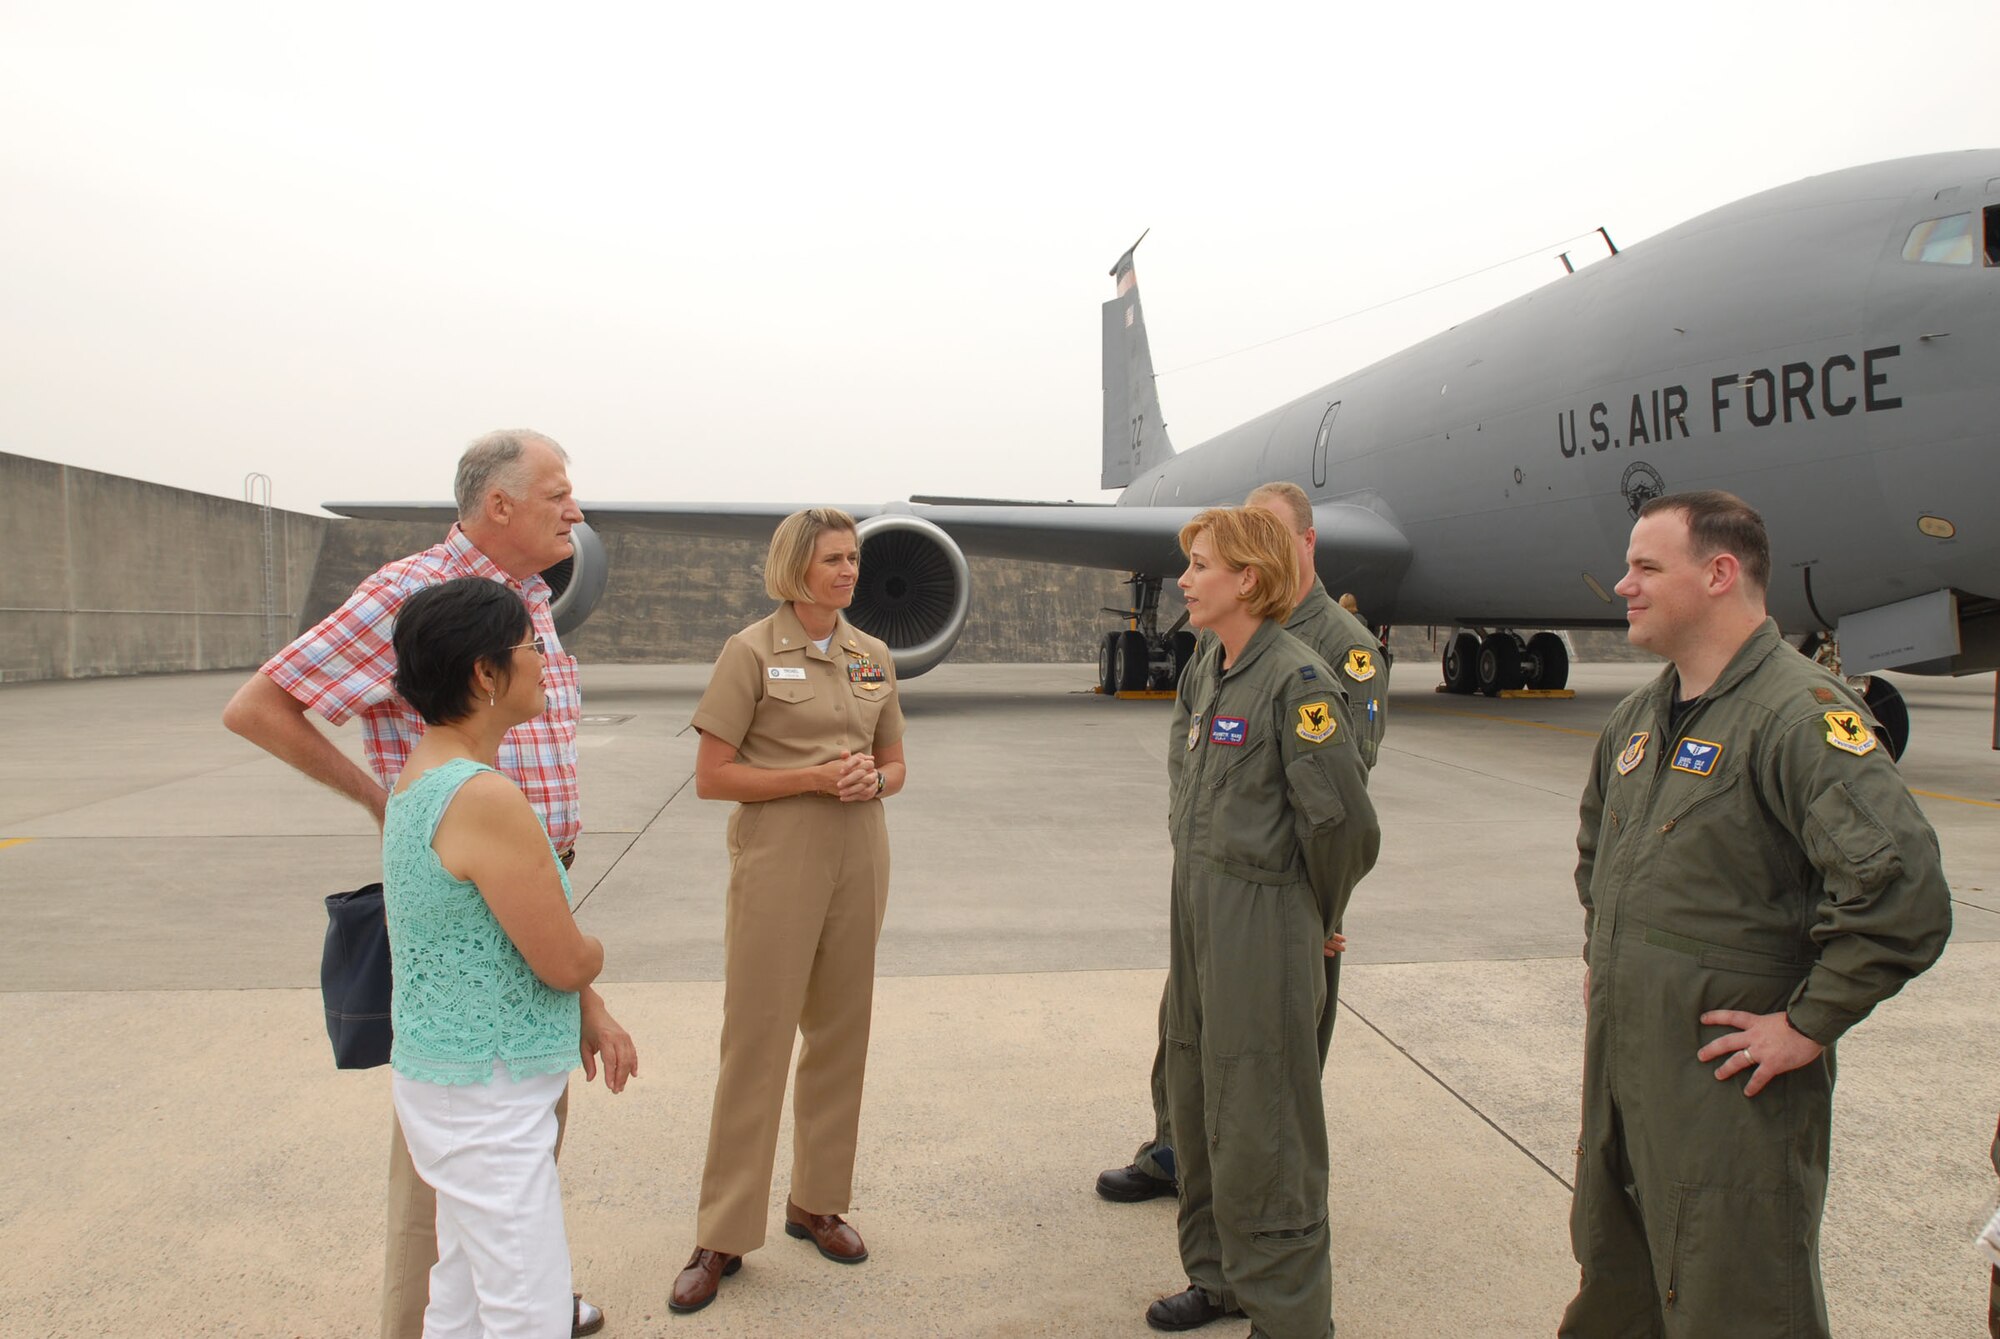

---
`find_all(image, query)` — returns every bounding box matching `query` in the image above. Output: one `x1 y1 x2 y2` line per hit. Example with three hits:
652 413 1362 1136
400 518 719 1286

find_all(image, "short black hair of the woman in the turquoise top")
392 576 530 725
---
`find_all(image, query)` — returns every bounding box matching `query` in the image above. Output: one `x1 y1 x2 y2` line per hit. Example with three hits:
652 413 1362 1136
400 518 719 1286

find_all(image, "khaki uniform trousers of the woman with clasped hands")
694 795 888 1255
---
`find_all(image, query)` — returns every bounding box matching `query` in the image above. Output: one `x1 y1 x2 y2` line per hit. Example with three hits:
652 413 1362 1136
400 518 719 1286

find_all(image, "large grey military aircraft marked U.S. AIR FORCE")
328 150 2000 755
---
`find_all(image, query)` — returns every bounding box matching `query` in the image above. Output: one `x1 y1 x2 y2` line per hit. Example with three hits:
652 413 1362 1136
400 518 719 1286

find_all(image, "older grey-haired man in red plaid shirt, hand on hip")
222 432 638 1339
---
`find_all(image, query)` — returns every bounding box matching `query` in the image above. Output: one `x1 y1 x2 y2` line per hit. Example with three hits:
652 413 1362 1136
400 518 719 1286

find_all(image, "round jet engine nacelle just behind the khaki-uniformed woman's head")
848 512 972 679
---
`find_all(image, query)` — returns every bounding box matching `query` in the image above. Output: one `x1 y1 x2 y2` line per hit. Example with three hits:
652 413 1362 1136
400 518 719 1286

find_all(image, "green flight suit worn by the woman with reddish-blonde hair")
1166 624 1382 1339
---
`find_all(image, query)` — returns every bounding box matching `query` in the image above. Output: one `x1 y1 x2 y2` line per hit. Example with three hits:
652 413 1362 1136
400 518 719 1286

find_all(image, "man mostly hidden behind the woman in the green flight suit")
1098 482 1388 1329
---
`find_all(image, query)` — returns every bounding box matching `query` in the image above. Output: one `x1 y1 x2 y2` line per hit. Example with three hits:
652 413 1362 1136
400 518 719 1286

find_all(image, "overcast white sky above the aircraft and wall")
0 0 2000 512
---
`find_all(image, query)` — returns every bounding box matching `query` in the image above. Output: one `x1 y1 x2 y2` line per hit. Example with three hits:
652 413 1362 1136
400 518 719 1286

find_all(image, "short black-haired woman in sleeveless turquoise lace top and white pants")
382 578 604 1339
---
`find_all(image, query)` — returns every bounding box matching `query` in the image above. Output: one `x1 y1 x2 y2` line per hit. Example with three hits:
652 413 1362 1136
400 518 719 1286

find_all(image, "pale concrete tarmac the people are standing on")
0 664 2000 1339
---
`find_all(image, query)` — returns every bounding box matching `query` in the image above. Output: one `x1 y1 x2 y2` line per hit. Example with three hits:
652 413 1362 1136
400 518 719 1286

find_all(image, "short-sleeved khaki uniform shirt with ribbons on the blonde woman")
694 604 902 769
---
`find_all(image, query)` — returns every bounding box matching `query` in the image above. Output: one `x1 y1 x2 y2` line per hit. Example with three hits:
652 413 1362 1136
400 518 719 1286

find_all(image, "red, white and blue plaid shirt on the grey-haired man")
264 526 584 851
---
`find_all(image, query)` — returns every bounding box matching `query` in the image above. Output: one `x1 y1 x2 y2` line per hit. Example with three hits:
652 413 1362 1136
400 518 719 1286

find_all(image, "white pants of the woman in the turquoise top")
394 1065 570 1339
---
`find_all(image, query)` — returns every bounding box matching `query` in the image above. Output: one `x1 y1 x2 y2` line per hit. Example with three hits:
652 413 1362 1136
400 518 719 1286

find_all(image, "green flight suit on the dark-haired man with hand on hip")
1558 620 1952 1339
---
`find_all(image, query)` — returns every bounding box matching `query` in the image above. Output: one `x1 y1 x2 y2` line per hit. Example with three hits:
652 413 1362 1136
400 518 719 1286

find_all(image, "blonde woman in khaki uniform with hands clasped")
668 508 904 1311
